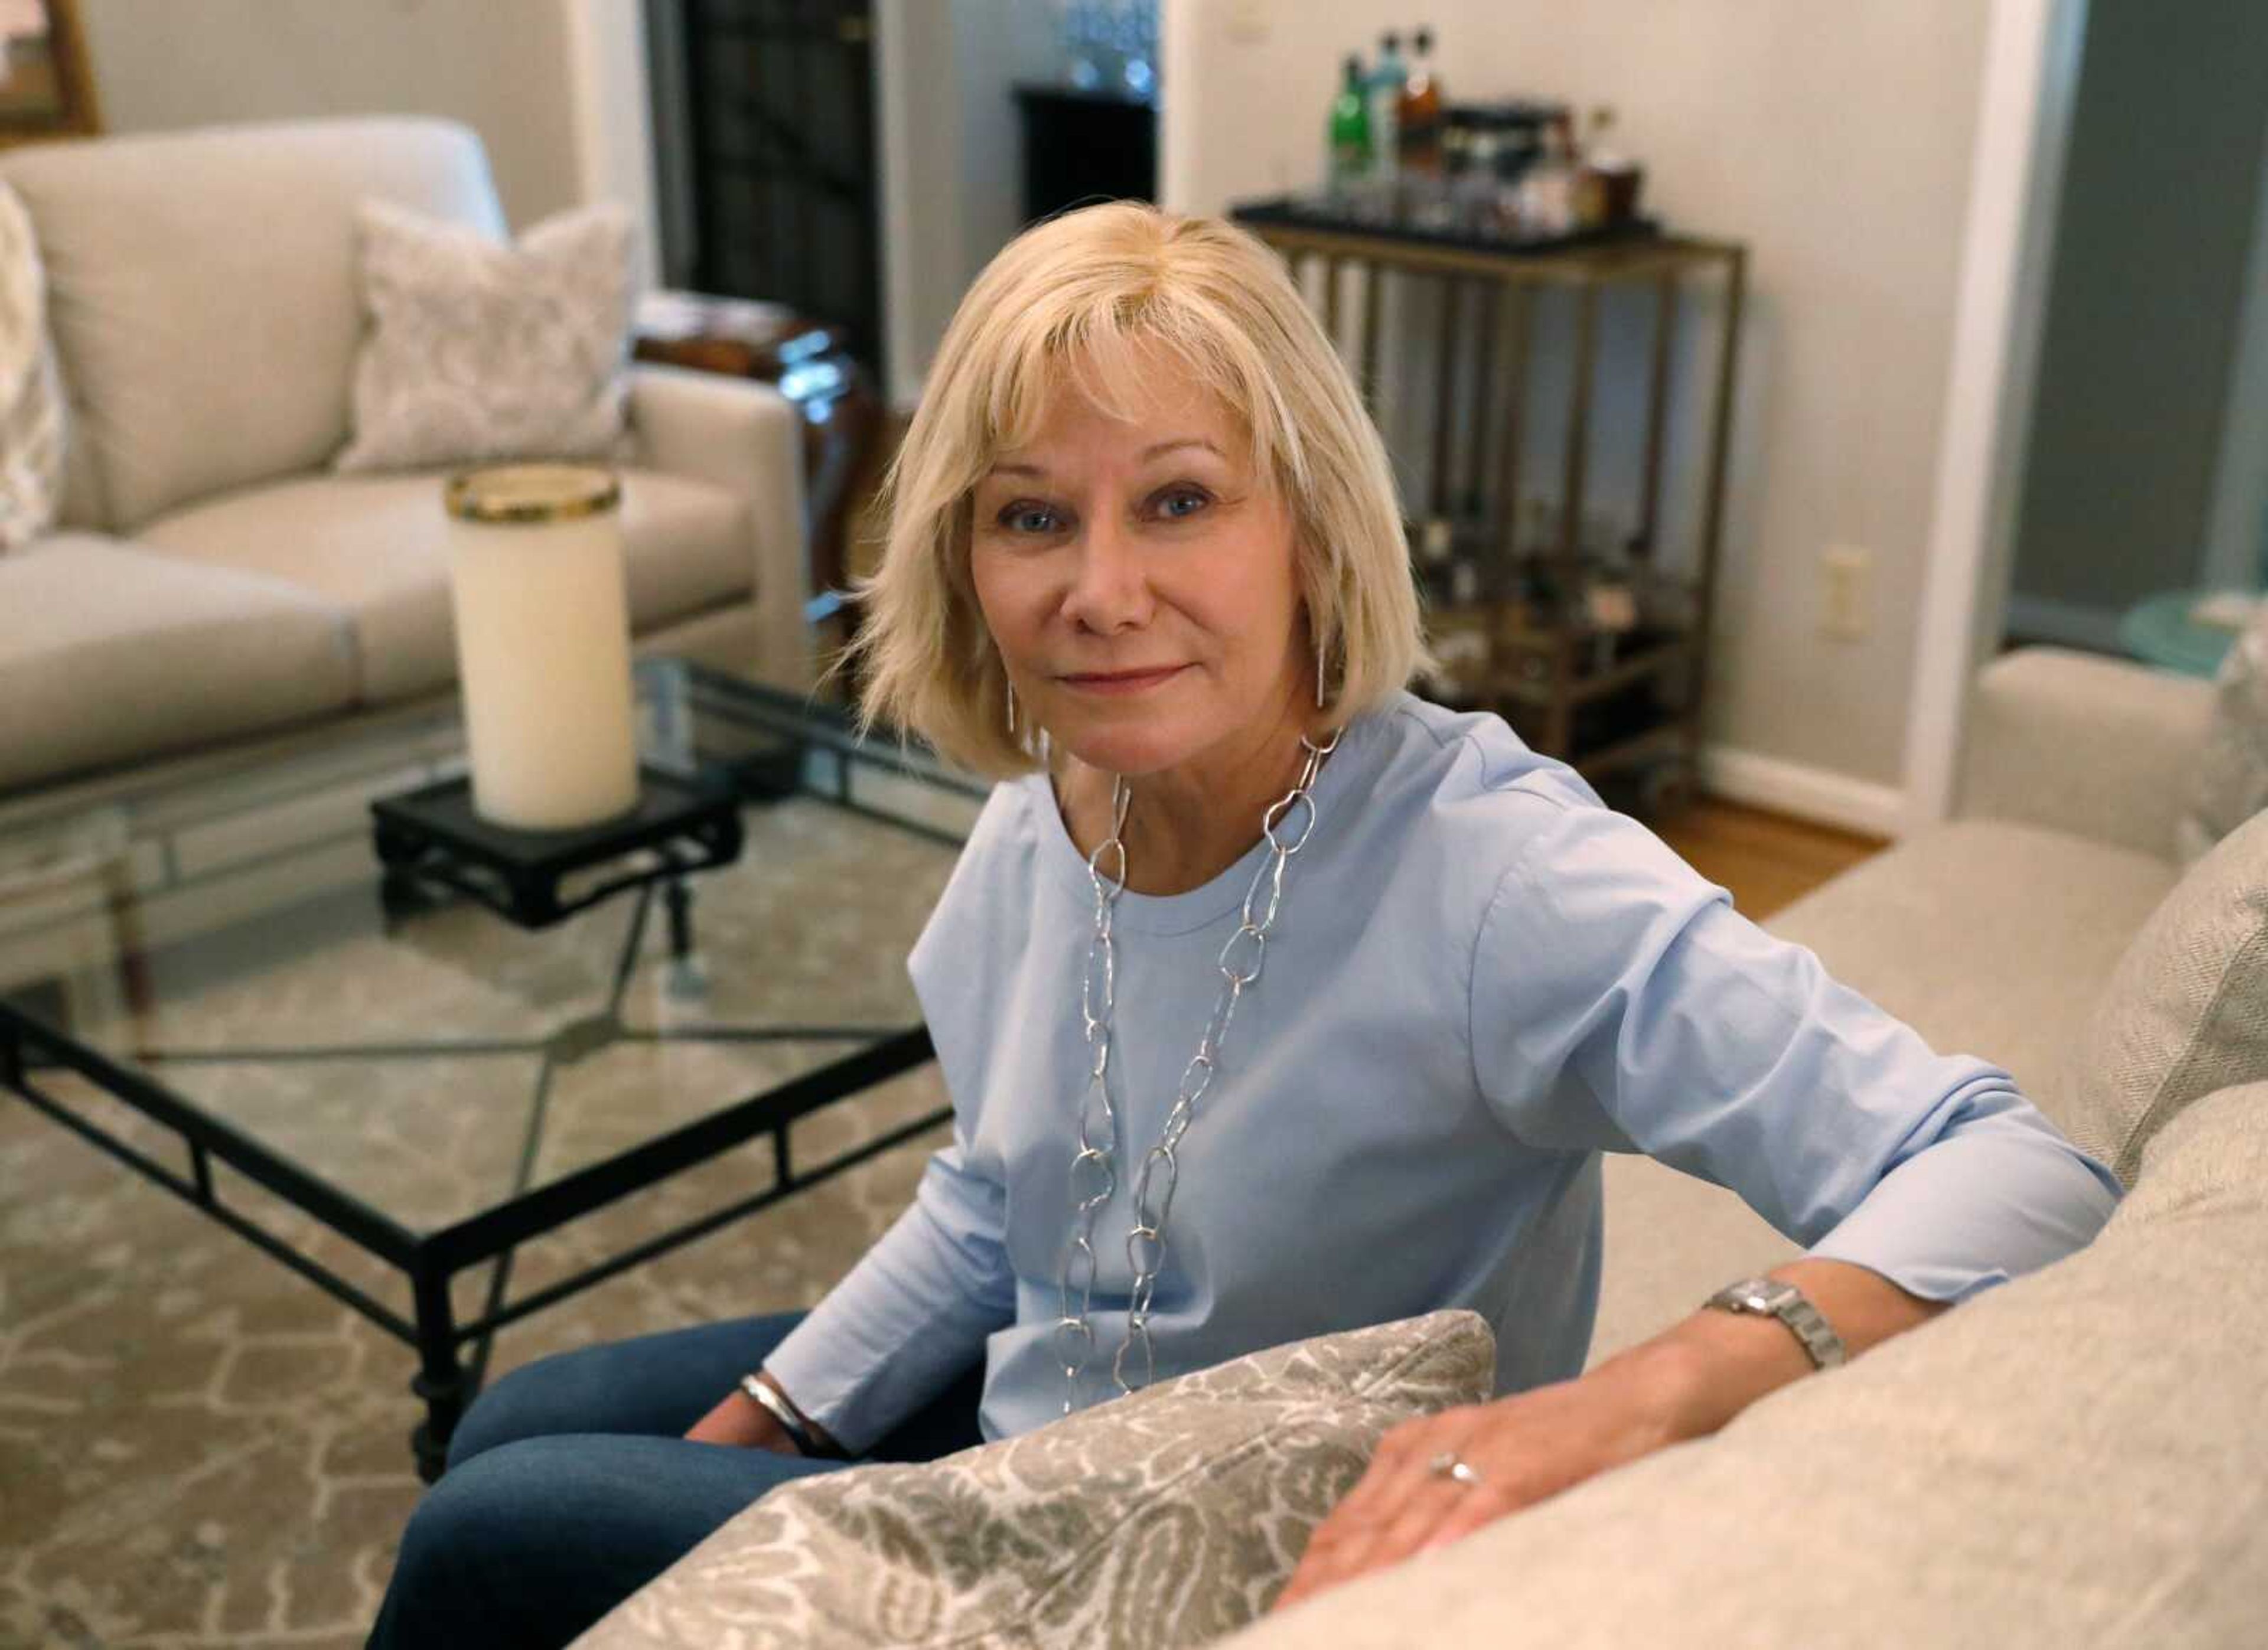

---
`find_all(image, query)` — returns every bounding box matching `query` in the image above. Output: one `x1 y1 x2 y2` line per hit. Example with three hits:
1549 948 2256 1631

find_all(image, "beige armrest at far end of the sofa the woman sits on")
1953 646 2214 859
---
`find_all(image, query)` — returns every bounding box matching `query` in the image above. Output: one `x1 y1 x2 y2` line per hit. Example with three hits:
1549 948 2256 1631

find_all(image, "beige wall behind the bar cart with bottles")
1166 0 1987 787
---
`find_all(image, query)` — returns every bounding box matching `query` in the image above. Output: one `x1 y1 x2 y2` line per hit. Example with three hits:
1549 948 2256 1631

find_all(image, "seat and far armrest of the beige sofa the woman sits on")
1592 648 2204 1362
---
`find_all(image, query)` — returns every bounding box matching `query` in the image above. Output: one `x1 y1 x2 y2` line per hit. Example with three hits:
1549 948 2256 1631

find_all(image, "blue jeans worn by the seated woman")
370 1312 985 1650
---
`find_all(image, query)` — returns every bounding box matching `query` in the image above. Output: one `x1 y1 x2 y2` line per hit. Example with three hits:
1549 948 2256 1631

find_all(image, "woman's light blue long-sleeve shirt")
767 693 2119 1450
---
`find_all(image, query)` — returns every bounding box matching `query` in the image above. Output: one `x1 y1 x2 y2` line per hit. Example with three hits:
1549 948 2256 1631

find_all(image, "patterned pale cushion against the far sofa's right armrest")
333 200 633 471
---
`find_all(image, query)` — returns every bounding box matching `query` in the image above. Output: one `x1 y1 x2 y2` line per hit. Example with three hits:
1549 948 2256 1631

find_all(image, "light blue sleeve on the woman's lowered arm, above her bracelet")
764 1140 1016 1455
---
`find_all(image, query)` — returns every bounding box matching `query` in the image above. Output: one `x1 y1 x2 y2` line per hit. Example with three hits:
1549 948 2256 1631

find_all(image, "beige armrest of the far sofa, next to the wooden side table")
631 363 814 692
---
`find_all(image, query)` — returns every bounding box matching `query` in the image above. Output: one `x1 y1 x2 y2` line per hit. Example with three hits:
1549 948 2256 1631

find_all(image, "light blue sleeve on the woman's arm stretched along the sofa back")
1469 775 2120 1301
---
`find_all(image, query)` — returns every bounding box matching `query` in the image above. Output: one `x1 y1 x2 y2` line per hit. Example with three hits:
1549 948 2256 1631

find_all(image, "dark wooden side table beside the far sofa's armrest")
631 290 882 623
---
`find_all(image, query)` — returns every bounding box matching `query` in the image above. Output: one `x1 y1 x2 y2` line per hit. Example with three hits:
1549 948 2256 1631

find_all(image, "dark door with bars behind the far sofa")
651 0 885 376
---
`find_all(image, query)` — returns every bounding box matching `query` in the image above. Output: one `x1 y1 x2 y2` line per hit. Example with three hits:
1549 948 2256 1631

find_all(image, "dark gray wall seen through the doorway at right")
2009 0 2268 644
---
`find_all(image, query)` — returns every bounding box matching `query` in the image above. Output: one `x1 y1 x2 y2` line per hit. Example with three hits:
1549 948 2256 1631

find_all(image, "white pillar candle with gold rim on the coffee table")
447 465 637 830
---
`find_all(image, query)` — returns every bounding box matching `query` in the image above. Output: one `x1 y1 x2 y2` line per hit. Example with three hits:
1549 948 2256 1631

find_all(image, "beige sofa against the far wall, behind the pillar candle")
0 120 812 795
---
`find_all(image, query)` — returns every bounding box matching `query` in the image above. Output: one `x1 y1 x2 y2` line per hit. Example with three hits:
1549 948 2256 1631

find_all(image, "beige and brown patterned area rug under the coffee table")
0 797 953 1650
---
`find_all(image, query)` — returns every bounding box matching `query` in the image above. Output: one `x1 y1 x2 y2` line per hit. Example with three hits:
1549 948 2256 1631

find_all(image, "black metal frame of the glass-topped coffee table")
0 684 989 1482
